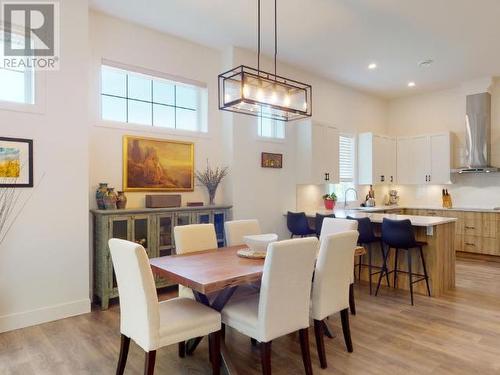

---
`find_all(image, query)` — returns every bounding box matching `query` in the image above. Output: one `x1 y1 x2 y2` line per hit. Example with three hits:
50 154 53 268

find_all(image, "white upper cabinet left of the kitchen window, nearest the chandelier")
295 121 339 185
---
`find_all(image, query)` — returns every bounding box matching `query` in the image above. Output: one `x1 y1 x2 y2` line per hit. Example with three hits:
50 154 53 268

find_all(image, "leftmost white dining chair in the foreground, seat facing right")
109 239 221 375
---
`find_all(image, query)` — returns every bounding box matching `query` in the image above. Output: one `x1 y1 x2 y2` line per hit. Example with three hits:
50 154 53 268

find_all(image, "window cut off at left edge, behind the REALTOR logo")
0 34 35 104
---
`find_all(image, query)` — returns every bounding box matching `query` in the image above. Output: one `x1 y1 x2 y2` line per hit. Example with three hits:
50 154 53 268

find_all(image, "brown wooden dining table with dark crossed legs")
150 245 365 375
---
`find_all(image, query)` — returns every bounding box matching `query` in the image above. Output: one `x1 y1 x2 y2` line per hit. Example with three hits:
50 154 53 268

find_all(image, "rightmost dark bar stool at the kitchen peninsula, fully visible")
375 219 431 306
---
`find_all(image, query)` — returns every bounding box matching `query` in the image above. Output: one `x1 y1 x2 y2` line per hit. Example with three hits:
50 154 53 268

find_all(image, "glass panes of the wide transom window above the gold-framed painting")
101 65 207 132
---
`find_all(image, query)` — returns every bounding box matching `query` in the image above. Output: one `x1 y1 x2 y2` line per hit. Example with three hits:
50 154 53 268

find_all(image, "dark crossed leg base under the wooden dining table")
186 286 237 375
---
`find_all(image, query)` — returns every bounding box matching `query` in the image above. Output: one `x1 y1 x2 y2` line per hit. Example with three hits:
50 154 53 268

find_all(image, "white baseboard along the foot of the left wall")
0 298 90 333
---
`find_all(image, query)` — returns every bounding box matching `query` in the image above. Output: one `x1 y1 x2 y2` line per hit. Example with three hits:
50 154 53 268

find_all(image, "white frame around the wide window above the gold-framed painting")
96 59 210 138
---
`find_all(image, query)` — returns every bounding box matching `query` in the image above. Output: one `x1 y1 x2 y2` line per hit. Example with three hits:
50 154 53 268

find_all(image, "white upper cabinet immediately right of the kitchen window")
358 133 397 185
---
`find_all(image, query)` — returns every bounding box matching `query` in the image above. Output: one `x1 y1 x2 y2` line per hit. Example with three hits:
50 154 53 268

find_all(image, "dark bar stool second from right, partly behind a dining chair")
347 216 390 295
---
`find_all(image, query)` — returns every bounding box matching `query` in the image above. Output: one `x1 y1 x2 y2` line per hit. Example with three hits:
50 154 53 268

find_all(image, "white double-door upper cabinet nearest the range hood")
397 133 451 185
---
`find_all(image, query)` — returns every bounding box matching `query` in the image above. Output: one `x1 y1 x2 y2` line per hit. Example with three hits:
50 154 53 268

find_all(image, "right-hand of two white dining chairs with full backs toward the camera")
311 230 358 368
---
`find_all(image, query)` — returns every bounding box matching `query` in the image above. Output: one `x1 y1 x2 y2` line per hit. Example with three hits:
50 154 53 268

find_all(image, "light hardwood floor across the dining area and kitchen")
0 260 500 375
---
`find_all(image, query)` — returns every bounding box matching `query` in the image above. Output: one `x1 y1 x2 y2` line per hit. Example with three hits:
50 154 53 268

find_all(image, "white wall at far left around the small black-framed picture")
0 0 90 332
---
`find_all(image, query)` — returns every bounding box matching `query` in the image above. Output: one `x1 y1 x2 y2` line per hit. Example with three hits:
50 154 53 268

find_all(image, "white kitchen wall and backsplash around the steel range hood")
388 80 500 208
